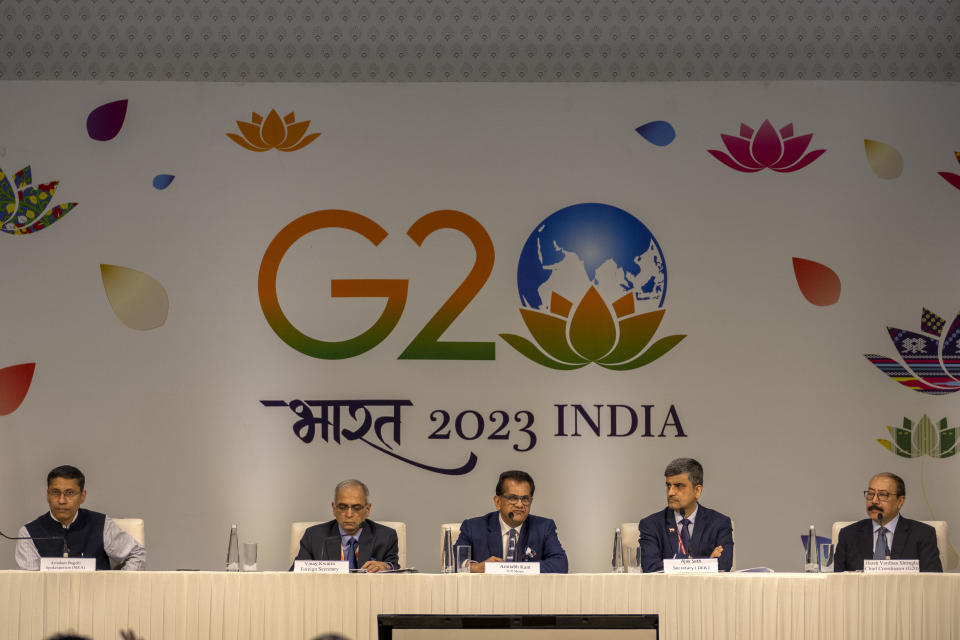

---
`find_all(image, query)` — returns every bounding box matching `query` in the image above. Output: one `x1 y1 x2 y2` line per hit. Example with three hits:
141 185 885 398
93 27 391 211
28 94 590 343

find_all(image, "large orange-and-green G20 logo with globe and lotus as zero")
258 203 686 370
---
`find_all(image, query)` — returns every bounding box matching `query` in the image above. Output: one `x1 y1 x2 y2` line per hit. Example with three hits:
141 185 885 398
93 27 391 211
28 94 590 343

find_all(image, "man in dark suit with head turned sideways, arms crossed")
639 458 733 573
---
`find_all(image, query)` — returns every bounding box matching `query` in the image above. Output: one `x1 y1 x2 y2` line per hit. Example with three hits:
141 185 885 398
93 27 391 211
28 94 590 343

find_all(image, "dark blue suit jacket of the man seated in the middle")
454 511 567 573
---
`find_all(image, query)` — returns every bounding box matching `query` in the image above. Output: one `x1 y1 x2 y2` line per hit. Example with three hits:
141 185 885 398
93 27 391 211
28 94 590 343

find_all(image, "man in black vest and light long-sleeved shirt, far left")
16 465 147 571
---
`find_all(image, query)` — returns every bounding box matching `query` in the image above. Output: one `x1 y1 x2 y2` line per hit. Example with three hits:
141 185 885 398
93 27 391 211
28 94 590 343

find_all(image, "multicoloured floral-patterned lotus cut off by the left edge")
0 166 77 235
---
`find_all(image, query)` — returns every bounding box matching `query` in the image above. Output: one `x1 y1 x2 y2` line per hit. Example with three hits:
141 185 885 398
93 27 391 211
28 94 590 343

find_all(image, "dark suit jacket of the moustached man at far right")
833 516 943 571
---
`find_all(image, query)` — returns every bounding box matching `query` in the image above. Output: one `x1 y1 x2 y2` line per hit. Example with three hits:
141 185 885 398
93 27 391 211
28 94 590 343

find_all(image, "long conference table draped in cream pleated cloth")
0 571 960 640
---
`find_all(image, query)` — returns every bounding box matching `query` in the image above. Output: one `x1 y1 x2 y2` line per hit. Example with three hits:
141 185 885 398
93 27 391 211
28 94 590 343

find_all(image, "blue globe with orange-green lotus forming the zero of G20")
500 203 686 371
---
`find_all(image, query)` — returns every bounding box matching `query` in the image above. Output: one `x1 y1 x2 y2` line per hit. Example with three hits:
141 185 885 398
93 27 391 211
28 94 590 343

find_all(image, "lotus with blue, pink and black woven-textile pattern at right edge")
865 309 960 395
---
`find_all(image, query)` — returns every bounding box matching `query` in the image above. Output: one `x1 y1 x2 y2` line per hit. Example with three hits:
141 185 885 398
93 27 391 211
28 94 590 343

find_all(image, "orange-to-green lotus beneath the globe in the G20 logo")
500 287 686 371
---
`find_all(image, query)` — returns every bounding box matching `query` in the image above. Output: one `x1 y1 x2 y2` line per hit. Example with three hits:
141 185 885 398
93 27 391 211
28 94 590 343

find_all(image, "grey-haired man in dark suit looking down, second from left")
295 480 400 573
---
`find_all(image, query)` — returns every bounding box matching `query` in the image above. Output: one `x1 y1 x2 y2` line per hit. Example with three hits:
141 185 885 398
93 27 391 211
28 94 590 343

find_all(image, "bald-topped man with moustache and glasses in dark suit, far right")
833 472 943 571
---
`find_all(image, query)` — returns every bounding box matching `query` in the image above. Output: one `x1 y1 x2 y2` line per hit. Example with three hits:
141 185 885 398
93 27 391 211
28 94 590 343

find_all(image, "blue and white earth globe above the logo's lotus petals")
517 203 667 312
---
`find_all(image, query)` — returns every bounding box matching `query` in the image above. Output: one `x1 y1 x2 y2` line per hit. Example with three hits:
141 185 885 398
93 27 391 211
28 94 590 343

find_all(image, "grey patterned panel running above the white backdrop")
0 0 960 82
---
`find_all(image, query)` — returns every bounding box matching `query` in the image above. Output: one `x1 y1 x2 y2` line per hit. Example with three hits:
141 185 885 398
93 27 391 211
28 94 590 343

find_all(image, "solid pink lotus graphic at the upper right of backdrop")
707 120 826 173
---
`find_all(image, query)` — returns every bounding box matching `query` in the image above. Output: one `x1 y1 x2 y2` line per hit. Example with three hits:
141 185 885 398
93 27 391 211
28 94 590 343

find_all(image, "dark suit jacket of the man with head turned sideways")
640 504 733 573
